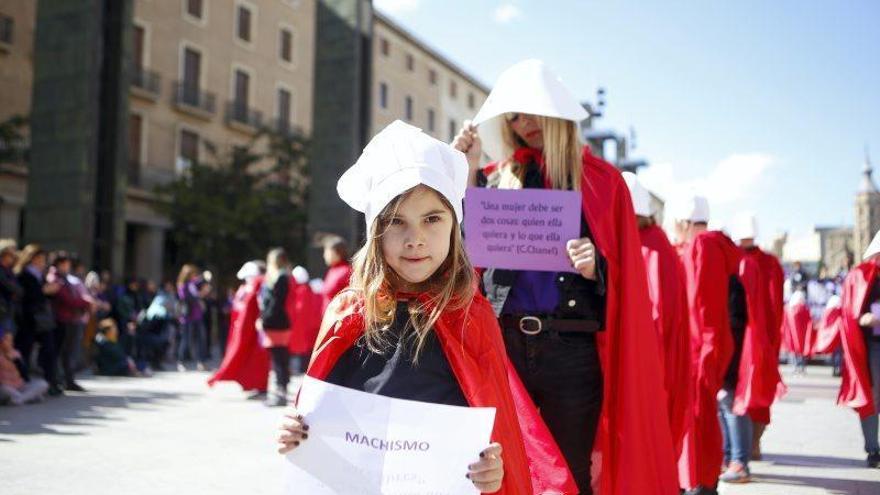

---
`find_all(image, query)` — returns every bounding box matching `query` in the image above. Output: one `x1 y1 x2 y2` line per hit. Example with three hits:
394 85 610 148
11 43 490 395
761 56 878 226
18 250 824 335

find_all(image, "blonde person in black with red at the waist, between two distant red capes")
257 248 292 407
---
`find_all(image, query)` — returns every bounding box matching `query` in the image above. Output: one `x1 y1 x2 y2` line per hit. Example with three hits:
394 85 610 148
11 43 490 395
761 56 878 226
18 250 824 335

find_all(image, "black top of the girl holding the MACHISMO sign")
325 301 468 406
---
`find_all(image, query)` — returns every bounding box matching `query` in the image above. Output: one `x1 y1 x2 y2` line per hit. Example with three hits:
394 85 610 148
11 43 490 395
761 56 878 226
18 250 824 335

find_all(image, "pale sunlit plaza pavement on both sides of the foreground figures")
0 366 880 495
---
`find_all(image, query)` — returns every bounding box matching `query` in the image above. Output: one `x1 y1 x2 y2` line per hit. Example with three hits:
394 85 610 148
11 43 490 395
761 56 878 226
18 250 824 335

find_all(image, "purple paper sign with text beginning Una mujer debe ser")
464 187 581 272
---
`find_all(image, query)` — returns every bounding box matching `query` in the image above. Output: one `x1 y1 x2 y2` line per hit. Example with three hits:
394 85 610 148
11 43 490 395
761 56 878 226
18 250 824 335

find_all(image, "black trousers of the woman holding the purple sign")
503 328 603 495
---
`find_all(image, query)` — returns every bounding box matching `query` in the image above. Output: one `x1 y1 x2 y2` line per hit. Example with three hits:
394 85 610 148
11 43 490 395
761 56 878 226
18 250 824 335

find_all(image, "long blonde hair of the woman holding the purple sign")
501 115 583 191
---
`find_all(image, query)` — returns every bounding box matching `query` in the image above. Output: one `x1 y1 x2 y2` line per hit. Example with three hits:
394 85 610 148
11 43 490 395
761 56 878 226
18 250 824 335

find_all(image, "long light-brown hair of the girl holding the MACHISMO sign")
349 186 475 362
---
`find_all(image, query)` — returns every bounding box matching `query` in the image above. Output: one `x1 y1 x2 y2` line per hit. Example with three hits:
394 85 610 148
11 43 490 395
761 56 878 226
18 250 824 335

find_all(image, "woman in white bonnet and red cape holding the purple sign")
453 60 678 495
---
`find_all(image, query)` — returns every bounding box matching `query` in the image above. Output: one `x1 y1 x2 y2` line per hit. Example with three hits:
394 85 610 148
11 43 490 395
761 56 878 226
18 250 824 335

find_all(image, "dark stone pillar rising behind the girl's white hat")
308 0 373 276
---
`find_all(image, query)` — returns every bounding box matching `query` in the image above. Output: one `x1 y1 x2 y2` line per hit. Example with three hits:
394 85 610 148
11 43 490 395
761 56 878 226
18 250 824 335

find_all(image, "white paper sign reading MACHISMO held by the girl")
285 376 495 495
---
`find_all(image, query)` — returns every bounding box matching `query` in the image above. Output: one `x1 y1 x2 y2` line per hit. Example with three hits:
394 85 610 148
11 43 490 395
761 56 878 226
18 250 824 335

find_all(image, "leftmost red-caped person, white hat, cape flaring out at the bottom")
208 261 269 398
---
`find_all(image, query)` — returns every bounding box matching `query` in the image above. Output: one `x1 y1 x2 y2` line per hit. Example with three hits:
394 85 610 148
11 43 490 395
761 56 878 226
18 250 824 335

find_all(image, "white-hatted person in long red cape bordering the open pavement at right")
731 214 785 460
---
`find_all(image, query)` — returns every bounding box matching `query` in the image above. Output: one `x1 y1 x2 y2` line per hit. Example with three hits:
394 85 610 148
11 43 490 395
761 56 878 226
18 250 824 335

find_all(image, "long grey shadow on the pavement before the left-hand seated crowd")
0 391 192 442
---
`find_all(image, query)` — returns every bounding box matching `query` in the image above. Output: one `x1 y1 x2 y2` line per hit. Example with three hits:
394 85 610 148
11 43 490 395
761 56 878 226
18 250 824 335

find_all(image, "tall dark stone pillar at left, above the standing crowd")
24 0 133 274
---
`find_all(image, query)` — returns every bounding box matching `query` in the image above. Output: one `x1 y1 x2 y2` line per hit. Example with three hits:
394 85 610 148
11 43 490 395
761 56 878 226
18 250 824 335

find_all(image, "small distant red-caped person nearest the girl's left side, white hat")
287 266 323 373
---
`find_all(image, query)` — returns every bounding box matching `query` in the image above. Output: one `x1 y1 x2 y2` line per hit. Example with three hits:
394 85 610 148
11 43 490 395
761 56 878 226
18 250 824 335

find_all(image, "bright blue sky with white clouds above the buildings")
374 0 880 247
